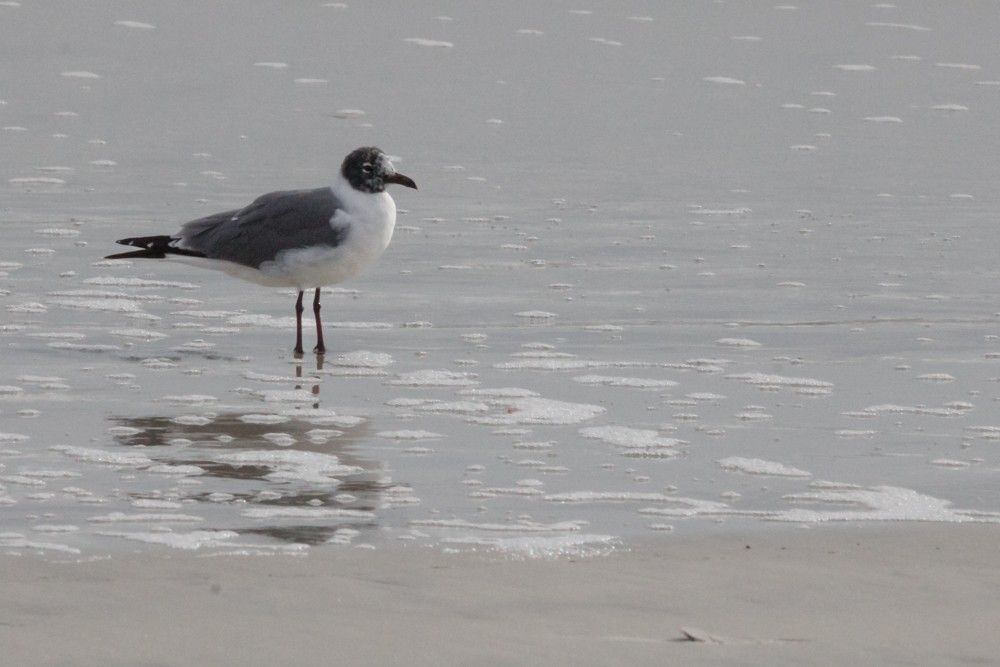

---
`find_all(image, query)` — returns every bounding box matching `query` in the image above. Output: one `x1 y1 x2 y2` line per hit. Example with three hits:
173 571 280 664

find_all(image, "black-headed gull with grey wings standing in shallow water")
106 147 417 354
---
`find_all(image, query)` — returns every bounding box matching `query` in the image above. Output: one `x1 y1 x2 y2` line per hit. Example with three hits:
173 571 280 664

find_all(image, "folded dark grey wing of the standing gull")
177 188 347 268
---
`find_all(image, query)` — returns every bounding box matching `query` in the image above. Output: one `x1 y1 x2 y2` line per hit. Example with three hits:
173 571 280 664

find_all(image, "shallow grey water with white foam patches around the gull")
0 0 1000 555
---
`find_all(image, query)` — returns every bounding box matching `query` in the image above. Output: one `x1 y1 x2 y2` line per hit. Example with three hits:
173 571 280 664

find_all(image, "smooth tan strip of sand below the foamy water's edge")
0 524 1000 667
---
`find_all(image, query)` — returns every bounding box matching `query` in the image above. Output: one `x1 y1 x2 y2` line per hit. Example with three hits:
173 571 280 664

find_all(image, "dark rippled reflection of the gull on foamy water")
110 366 392 544
